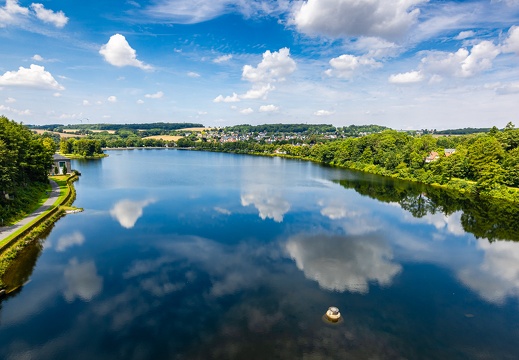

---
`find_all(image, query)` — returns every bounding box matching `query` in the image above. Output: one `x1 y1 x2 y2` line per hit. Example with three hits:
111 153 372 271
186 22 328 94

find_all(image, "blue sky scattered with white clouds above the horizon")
0 0 519 129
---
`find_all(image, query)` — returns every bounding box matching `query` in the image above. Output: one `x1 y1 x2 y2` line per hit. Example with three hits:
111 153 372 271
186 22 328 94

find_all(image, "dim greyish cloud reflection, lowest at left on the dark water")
63 258 103 302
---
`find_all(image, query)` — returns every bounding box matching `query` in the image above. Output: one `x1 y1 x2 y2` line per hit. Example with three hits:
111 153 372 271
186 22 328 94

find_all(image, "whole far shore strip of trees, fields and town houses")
27 123 519 203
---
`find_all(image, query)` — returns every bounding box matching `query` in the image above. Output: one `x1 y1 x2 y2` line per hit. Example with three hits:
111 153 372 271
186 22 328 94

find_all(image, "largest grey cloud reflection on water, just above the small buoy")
286 234 402 294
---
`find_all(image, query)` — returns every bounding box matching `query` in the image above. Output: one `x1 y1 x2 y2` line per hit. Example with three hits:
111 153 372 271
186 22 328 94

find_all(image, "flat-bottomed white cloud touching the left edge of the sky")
0 64 65 90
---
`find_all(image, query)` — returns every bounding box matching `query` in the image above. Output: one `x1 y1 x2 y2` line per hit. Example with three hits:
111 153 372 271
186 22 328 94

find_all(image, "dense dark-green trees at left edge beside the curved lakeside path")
0 116 56 224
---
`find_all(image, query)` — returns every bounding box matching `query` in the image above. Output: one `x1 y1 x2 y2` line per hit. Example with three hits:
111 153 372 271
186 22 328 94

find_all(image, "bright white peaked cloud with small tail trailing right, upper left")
99 34 153 70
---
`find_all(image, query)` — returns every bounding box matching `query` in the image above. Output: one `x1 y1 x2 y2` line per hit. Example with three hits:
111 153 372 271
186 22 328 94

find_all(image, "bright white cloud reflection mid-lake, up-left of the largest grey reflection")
241 190 290 222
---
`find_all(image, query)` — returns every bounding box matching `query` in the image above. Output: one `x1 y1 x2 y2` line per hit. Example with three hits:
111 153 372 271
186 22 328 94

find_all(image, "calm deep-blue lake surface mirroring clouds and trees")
0 149 519 359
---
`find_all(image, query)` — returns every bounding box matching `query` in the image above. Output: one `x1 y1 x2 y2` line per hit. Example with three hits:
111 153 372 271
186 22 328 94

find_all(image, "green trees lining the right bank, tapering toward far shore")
172 125 519 202
